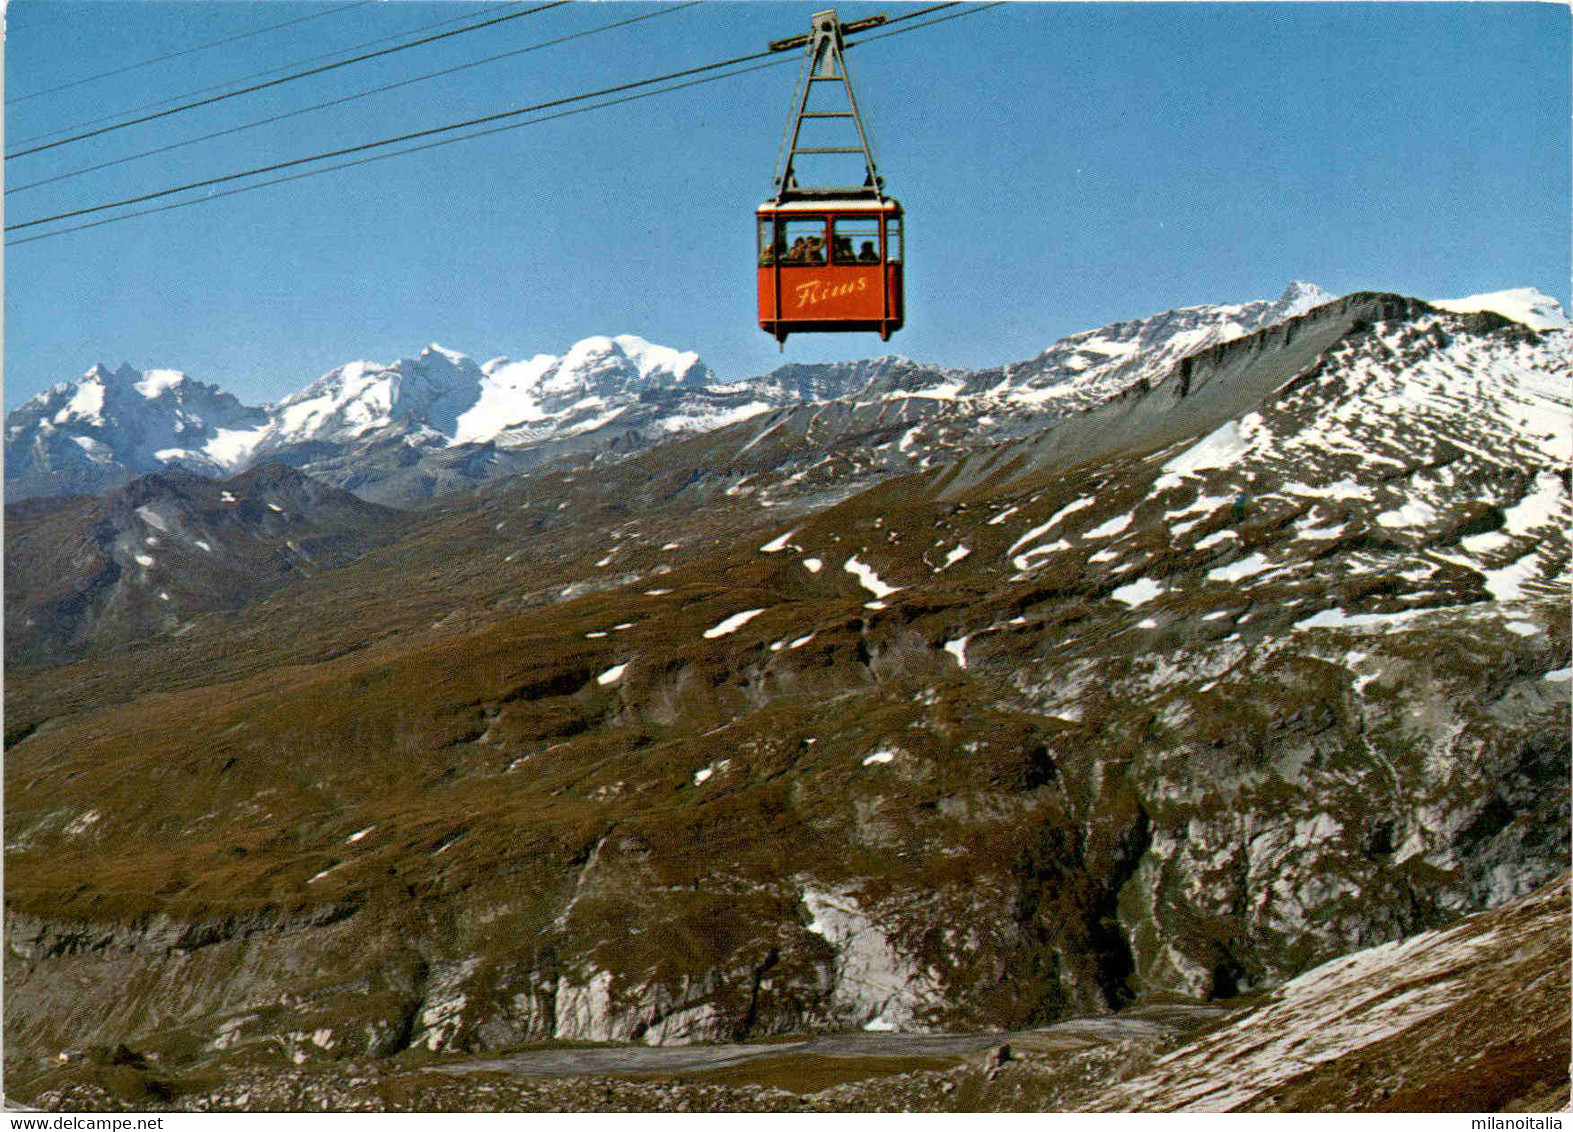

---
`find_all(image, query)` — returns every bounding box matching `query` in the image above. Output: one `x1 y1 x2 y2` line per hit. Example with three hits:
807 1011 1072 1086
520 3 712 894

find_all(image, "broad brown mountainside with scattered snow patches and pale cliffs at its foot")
6 284 1570 1106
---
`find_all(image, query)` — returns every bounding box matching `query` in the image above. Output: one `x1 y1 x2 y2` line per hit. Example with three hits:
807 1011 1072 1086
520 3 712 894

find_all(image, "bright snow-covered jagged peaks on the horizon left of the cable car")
6 335 729 475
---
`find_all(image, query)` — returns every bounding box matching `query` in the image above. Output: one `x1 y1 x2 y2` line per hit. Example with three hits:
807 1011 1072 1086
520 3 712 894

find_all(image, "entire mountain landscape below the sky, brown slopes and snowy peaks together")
5 285 1573 1110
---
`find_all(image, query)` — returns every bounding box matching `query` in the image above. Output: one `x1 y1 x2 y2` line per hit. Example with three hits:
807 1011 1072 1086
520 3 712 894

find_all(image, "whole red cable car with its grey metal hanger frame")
755 9 904 347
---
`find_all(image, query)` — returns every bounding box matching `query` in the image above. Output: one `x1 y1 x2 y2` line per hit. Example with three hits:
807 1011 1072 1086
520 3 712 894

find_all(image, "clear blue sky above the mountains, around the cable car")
5 0 1570 409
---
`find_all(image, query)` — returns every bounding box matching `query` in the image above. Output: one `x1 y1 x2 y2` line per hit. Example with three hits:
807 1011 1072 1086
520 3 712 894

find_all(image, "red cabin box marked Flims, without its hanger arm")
757 193 903 343
